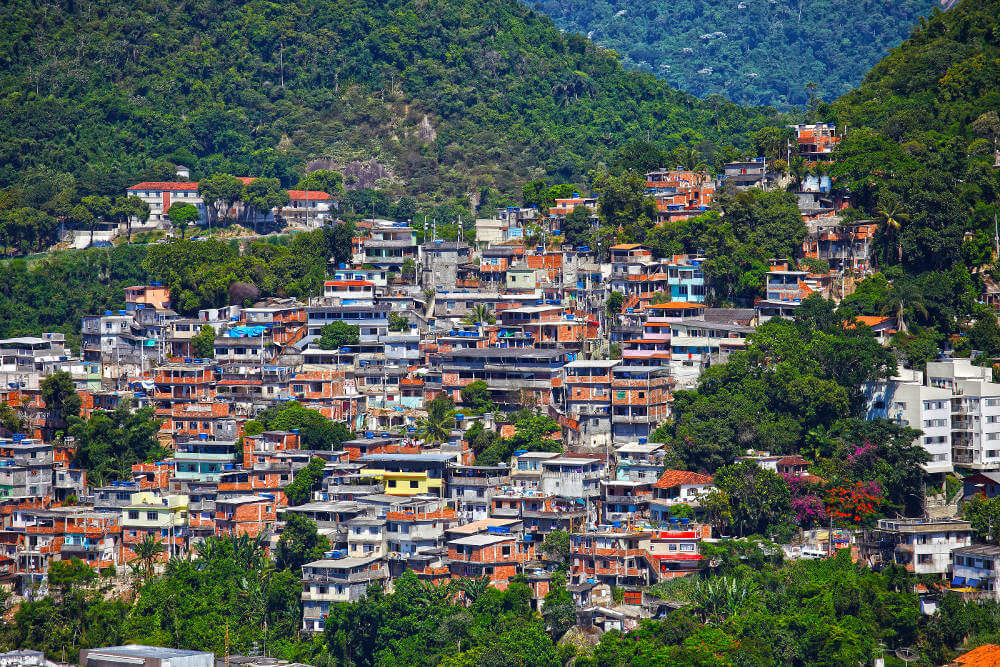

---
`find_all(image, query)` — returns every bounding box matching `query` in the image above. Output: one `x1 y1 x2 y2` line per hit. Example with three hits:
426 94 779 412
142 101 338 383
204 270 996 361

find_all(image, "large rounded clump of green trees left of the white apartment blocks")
656 298 896 472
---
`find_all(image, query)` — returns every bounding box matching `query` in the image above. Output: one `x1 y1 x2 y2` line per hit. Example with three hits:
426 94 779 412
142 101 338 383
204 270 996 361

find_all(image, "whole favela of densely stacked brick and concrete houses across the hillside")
9 125 1000 631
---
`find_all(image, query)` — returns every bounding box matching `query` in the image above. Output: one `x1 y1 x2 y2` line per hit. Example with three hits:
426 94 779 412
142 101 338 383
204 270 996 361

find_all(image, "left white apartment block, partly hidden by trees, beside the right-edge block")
864 369 956 473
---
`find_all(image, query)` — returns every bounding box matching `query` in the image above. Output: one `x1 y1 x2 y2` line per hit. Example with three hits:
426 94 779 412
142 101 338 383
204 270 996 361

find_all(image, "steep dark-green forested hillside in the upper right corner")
819 0 1000 272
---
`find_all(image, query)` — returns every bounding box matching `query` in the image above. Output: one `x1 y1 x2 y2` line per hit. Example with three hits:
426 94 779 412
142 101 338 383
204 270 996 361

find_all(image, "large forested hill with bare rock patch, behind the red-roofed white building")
0 0 763 206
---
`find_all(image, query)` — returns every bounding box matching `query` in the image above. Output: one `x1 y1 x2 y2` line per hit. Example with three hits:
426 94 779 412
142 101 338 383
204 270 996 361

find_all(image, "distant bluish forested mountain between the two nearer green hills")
527 0 937 108
